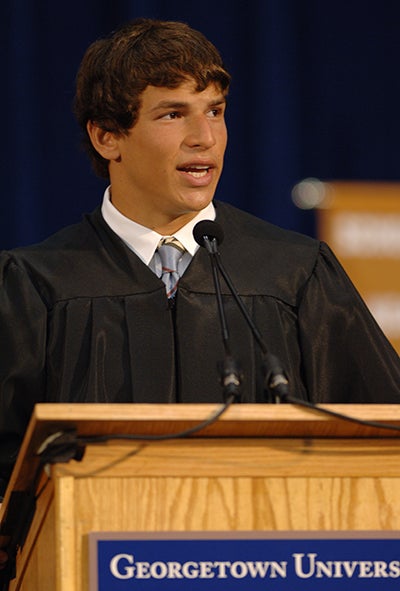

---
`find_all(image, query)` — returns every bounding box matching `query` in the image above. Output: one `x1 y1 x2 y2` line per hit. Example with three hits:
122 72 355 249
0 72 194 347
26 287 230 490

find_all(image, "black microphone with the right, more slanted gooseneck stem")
193 220 289 403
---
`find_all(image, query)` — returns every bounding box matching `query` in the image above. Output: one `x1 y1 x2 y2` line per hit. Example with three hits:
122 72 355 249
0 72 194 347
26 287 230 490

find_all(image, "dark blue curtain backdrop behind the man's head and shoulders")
0 0 400 248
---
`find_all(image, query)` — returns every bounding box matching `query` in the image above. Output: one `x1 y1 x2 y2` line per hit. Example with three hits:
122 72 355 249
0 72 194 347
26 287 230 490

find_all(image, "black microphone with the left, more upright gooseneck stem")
193 220 242 400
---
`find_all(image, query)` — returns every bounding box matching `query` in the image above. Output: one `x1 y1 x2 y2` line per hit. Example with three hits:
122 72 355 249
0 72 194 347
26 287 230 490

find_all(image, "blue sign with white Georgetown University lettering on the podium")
89 532 400 591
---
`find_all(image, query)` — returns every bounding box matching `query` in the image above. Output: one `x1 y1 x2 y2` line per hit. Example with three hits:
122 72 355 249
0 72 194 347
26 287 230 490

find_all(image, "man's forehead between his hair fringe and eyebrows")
141 80 225 111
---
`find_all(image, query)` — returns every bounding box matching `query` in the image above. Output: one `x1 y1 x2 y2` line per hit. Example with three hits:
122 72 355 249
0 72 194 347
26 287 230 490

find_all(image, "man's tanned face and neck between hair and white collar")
110 81 227 233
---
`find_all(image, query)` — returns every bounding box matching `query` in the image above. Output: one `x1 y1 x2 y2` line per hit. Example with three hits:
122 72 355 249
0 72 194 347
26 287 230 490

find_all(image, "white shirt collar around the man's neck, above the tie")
101 187 215 265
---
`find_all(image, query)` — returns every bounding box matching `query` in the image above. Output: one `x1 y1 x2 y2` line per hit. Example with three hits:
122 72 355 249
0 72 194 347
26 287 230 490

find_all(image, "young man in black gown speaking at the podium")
0 20 400 492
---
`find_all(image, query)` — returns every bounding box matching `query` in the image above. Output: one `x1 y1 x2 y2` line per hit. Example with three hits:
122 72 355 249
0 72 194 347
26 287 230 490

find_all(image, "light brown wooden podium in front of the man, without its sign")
0 404 400 591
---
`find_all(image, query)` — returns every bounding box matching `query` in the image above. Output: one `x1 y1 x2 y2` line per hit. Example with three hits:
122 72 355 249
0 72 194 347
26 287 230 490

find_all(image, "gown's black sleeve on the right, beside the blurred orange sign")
299 243 400 404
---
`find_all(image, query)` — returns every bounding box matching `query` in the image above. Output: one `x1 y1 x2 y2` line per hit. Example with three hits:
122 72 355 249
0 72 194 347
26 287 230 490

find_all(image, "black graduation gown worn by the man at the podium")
0 202 400 490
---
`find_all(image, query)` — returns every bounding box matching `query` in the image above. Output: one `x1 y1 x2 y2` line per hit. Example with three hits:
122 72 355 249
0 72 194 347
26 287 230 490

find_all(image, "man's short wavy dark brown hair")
74 18 230 178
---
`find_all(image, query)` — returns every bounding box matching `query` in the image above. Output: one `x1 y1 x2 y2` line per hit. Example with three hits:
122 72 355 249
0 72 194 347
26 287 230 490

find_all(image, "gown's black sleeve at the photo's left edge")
0 253 47 494
